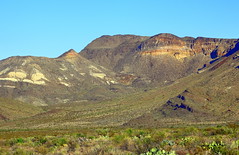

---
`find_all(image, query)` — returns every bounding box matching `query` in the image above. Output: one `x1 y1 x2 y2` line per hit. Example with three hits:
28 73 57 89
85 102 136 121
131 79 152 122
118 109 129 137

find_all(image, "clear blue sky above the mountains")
0 0 239 59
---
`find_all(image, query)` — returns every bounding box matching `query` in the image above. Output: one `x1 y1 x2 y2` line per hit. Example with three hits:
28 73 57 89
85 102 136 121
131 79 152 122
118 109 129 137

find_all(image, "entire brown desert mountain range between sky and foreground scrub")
0 33 239 129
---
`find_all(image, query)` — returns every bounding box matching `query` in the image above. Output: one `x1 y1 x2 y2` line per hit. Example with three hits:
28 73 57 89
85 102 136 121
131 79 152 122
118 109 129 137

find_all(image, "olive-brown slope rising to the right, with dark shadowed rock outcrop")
1 51 239 128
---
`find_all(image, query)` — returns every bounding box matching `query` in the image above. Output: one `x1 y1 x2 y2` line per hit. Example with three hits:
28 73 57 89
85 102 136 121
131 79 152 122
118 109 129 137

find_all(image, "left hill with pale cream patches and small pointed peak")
0 50 131 106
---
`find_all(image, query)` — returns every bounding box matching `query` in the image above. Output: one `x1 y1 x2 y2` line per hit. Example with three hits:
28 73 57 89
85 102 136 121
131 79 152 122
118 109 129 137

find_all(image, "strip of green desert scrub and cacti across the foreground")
0 124 239 155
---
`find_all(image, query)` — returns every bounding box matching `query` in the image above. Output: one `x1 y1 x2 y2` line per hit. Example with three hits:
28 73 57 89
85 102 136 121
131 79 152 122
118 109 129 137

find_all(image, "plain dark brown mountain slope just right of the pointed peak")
80 35 149 70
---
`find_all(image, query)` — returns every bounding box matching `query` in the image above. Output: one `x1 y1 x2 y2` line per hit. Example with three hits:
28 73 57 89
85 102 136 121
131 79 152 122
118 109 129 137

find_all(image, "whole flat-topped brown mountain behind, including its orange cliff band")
80 33 237 87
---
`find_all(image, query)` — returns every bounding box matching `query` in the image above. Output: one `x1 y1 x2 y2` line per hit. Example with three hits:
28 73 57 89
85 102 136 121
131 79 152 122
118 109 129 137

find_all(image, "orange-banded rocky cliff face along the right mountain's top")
139 34 237 59
